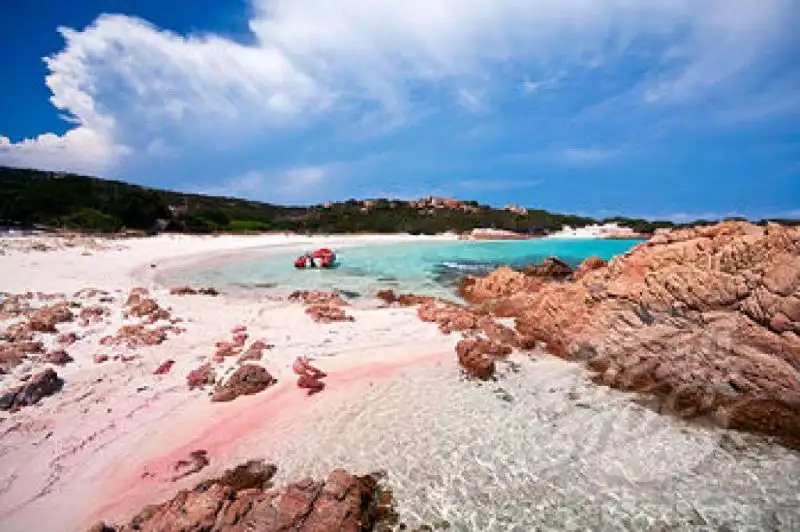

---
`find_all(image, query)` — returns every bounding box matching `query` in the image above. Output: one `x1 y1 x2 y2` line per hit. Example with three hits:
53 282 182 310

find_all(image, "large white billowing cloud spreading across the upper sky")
0 0 798 178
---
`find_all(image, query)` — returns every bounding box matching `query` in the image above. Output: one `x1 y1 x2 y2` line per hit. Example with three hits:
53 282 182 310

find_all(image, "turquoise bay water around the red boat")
170 239 640 297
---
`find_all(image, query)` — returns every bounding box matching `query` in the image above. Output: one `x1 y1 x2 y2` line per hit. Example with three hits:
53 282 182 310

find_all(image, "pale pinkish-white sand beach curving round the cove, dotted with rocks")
0 235 457 531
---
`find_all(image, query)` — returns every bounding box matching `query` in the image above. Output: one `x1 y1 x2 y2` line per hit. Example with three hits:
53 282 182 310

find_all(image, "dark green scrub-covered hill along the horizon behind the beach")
0 167 792 234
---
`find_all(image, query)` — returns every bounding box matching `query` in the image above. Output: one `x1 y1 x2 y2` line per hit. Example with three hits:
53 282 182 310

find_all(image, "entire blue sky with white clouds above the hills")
0 0 800 220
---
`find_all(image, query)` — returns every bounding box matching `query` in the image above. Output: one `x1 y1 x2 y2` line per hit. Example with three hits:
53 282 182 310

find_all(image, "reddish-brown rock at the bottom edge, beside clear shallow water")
91 460 394 532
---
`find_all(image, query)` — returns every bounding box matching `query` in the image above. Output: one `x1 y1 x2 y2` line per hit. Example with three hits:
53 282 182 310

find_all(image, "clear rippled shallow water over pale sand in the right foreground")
258 358 800 531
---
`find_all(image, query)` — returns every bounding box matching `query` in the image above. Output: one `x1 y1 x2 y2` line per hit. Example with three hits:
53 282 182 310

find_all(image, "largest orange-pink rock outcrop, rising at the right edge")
468 222 800 445
